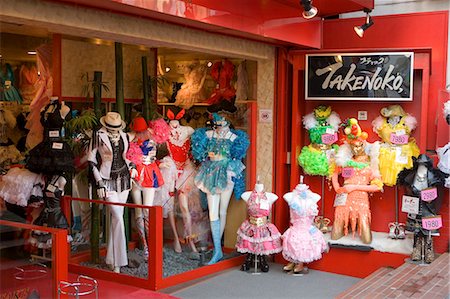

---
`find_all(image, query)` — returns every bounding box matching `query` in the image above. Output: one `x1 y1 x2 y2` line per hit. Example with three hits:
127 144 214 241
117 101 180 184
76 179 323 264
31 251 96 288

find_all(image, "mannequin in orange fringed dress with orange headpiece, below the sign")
331 118 383 244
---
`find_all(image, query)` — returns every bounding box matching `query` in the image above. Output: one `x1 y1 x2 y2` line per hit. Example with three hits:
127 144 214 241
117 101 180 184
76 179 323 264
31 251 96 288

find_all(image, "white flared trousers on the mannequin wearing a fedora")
106 190 129 272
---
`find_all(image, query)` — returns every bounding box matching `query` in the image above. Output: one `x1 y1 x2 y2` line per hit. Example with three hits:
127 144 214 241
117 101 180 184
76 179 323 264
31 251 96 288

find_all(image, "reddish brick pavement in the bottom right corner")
337 253 449 299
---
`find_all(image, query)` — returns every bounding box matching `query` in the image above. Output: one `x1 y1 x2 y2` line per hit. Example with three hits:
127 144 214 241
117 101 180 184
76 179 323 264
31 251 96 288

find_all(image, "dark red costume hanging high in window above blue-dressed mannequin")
208 59 237 113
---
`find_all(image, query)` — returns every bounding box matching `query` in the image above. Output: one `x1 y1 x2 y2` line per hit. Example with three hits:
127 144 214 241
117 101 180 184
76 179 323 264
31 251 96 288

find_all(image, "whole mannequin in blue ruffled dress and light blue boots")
192 113 249 264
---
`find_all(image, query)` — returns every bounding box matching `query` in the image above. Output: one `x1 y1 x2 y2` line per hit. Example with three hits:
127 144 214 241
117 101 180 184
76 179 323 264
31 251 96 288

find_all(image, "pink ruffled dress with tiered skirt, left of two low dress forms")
236 191 282 255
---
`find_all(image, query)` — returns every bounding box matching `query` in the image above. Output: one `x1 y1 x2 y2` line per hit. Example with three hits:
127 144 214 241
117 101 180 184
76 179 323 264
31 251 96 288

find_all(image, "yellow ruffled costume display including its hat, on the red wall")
372 105 420 186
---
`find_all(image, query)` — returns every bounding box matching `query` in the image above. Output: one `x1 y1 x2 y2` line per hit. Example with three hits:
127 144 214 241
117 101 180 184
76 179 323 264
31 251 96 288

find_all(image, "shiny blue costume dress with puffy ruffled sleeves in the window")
191 128 250 198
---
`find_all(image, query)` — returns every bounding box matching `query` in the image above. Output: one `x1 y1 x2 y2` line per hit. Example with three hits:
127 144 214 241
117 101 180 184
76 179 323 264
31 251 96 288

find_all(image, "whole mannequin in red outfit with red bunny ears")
165 109 198 259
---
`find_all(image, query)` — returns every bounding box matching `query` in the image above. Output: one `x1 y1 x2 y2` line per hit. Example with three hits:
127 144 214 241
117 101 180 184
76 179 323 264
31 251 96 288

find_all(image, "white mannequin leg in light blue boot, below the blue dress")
207 193 223 265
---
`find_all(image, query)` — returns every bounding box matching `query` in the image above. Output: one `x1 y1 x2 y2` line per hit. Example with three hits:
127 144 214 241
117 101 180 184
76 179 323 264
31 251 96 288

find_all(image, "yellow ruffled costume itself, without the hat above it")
374 108 420 186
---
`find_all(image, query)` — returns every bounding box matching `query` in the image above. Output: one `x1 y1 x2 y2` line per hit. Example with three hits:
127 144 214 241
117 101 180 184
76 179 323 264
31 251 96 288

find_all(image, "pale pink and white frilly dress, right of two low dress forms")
282 184 328 264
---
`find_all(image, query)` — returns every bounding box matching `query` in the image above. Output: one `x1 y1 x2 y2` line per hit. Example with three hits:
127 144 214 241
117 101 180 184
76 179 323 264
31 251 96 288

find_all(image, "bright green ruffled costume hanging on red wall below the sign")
298 106 341 177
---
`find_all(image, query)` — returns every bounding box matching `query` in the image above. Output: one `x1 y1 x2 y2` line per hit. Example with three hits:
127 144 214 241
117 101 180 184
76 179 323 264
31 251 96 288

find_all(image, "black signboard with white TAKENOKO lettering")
305 52 414 101
